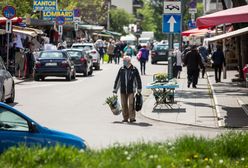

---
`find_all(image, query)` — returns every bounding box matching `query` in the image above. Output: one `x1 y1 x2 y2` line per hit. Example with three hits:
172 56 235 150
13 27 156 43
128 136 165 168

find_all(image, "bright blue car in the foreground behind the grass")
0 102 86 153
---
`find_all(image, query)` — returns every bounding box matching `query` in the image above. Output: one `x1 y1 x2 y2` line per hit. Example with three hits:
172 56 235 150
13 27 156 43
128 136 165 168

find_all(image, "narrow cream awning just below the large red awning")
204 27 248 42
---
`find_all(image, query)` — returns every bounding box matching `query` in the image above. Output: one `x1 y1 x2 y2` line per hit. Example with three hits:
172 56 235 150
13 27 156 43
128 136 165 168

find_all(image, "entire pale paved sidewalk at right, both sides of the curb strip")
141 68 248 128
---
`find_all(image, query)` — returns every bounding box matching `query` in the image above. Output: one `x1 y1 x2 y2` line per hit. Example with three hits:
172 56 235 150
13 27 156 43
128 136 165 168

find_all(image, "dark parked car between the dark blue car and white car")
64 49 93 76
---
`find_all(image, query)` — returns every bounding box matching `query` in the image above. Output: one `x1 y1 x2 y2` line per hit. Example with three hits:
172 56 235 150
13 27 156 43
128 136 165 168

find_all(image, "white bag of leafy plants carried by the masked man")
105 95 122 115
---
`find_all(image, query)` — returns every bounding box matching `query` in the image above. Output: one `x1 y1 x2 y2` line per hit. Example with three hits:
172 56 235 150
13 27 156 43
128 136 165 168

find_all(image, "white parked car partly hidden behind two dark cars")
72 43 100 70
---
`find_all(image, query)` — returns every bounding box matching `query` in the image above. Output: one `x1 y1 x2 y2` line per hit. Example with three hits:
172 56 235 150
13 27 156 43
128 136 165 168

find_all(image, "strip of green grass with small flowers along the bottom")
0 132 248 168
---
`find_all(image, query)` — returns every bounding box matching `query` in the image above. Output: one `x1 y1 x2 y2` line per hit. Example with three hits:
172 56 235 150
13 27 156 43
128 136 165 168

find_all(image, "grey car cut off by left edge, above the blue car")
0 57 15 103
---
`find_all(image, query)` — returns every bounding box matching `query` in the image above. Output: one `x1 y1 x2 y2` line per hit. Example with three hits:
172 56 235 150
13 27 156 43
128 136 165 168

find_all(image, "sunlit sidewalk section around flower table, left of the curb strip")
141 68 218 128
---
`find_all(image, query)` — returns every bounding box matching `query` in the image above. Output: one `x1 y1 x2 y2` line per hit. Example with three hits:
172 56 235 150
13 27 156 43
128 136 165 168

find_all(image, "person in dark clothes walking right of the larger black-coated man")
212 45 226 83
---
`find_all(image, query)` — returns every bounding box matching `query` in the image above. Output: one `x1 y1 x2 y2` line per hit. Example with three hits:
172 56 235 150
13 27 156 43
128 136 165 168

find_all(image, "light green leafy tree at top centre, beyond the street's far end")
110 9 134 34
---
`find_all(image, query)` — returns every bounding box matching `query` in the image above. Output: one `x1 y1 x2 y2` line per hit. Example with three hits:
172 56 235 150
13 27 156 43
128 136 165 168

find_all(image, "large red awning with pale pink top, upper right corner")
196 5 248 29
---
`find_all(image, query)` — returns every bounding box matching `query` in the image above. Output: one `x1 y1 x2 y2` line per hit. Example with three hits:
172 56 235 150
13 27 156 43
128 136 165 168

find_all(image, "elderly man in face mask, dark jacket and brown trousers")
113 56 142 123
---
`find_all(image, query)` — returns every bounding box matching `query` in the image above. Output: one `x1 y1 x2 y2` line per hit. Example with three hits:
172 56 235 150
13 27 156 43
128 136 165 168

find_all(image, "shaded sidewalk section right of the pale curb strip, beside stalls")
208 71 248 127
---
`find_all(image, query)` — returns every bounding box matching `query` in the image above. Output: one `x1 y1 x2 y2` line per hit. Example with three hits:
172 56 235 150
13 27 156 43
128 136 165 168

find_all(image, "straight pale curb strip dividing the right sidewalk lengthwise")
206 72 225 127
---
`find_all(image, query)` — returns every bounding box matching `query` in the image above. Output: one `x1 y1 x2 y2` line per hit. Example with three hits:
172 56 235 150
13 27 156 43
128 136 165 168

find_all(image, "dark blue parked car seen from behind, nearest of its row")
34 50 76 81
